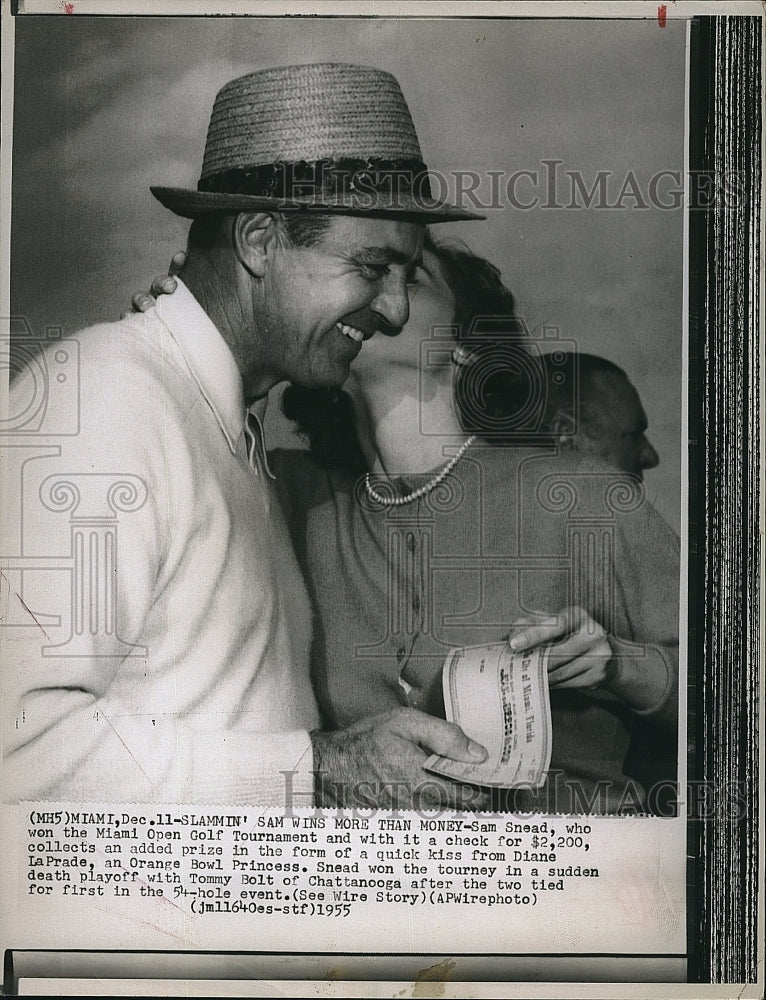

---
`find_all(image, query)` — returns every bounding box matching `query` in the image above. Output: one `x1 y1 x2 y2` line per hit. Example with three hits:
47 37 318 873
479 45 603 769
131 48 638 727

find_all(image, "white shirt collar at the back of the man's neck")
157 278 246 452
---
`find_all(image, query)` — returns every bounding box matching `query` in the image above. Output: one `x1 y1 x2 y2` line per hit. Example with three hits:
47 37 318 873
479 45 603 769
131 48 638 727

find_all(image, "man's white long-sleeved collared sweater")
6 282 318 805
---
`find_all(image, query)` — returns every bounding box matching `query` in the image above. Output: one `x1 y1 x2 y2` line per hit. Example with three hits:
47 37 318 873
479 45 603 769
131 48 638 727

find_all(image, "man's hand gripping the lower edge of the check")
311 708 489 810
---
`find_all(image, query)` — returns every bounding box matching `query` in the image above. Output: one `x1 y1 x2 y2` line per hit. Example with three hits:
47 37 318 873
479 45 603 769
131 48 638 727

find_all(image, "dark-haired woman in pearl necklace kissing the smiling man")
141 239 679 812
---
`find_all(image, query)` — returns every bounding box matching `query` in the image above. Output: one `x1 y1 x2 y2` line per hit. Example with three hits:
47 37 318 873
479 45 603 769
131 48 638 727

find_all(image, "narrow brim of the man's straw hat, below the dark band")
149 187 486 225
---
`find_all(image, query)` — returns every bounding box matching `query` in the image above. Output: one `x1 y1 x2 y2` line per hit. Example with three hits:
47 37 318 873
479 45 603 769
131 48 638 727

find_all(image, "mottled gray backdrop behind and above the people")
11 16 685 529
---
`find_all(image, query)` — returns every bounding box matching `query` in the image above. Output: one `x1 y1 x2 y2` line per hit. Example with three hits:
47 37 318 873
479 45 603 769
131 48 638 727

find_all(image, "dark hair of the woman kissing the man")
282 231 536 474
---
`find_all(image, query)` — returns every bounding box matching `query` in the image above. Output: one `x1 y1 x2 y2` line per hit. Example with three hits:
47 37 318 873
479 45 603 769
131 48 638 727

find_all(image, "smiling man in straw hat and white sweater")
6 64 484 806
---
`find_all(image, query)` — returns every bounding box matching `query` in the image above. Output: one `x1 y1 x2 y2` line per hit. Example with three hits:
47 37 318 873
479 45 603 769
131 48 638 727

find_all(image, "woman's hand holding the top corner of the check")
508 607 615 691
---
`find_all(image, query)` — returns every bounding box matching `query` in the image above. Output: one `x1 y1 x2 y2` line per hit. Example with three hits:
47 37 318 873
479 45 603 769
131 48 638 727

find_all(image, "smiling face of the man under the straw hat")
260 216 424 387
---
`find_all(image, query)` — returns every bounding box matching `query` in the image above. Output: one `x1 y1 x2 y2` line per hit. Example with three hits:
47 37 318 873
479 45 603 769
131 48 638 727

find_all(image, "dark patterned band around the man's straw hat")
197 158 432 209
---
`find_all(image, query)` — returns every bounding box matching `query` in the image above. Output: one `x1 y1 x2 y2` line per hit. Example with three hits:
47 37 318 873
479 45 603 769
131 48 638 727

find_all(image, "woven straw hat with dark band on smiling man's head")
151 63 483 223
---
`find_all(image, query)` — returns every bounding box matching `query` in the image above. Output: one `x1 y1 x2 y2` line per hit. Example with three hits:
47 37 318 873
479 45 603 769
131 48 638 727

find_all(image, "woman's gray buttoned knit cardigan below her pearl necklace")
272 443 680 812
